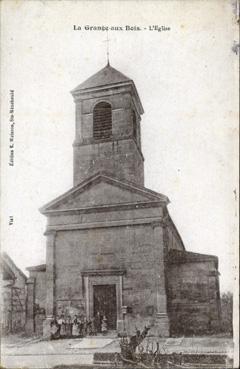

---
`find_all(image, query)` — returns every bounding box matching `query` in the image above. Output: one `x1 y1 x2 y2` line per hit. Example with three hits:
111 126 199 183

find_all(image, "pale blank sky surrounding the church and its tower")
2 1 237 290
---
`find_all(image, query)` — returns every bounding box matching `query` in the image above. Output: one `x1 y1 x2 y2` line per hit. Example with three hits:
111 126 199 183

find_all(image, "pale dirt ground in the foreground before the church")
1 335 233 369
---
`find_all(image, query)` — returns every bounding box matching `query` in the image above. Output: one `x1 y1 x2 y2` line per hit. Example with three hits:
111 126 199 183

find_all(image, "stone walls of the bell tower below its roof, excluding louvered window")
73 86 144 185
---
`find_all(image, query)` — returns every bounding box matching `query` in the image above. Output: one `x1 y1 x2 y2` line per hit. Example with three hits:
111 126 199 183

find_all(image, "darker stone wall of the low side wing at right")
167 252 220 335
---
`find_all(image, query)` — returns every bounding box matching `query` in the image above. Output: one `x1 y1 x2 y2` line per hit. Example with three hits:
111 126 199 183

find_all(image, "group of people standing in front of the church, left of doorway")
51 312 107 339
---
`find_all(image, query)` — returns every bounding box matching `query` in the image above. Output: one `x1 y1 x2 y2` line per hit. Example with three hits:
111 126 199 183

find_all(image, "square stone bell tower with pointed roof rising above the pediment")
71 63 144 186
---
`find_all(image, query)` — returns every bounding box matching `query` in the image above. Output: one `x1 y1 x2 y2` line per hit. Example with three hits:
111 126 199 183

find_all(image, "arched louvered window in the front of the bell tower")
93 102 112 140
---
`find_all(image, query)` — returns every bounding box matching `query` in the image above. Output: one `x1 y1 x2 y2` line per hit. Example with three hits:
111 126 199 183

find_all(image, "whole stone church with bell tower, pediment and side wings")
28 64 220 336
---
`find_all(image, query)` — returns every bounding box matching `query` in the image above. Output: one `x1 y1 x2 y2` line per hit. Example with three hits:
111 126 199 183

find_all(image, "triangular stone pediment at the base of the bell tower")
40 174 168 213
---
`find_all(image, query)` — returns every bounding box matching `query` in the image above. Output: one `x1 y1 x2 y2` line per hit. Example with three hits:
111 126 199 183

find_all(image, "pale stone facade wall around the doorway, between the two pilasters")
56 226 154 306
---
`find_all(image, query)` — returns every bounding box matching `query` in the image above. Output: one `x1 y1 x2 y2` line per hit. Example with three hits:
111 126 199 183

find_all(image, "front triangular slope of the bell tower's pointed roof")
72 63 132 92
